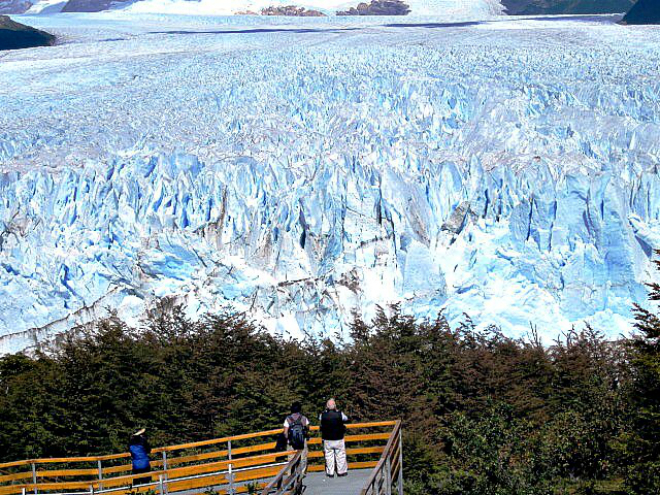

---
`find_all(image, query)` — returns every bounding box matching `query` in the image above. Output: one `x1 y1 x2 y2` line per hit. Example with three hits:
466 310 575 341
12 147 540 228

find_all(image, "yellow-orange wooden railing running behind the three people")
0 421 397 495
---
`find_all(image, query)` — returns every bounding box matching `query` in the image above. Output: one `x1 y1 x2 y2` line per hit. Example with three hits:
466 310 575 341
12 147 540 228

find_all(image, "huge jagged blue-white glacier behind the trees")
0 12 660 352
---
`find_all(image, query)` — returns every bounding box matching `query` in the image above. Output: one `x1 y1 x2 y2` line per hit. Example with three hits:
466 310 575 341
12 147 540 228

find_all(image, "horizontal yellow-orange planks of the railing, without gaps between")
0 421 397 495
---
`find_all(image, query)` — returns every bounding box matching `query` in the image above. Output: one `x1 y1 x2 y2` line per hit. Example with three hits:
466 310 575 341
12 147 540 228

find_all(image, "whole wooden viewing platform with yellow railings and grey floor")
0 421 403 495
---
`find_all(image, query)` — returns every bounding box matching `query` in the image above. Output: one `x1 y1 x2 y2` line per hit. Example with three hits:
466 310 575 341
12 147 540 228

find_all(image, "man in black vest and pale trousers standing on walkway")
319 399 348 478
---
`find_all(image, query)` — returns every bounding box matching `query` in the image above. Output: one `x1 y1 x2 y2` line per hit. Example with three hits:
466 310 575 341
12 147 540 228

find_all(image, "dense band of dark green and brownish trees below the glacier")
0 258 660 495
